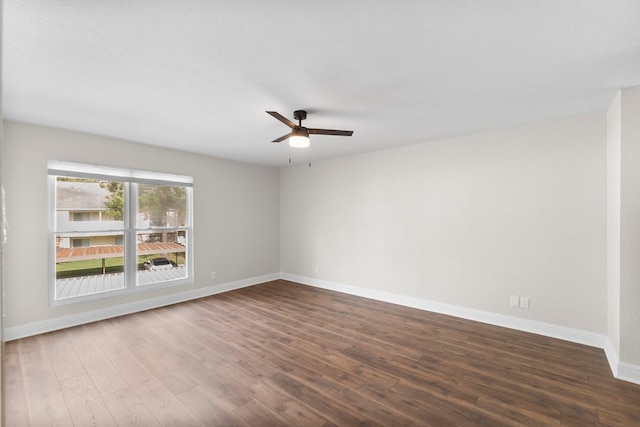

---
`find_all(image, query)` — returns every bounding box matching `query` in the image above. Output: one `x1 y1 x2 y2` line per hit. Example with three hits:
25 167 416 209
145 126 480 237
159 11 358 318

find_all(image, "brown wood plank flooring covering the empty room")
4 280 640 427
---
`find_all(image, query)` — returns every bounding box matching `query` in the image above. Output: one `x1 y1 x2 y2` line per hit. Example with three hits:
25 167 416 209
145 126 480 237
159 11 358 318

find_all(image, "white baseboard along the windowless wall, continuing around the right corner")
281 273 640 384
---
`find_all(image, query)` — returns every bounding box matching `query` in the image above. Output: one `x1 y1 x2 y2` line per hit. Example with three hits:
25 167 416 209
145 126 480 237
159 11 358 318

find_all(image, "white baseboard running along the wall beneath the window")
3 273 280 341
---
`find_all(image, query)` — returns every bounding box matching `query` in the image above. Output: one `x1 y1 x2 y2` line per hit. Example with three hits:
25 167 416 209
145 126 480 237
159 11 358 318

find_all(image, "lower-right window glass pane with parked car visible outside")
137 230 187 285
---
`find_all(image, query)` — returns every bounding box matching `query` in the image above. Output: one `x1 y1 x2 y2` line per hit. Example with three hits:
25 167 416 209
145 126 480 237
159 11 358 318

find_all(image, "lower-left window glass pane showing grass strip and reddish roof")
55 233 125 299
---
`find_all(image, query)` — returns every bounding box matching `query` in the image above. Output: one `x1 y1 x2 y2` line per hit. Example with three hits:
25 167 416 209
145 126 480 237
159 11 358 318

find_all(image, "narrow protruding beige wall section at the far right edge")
607 87 640 372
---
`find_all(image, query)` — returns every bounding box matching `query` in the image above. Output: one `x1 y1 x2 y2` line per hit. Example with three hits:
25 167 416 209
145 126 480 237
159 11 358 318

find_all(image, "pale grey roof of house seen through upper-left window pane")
56 181 110 211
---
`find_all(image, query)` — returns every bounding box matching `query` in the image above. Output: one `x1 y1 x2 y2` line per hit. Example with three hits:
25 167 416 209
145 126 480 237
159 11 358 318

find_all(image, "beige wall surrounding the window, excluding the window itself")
2 121 280 328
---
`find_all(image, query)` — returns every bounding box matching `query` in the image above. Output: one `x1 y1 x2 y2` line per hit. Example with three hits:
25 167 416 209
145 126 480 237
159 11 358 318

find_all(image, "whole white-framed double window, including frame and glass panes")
49 161 193 303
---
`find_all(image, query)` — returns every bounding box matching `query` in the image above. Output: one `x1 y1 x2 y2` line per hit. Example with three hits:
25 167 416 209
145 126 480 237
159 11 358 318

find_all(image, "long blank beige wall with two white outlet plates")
280 113 607 335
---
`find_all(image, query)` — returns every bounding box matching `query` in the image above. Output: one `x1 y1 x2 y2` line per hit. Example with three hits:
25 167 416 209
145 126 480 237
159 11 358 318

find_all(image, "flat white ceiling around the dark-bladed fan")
3 0 640 166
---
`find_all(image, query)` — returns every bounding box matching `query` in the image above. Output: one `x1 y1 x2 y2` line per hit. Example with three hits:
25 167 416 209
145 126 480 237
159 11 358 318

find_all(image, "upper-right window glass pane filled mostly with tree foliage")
136 184 187 228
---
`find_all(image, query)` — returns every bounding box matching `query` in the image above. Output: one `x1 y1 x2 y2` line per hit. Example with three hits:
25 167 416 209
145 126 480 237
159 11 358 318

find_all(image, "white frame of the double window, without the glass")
48 160 194 305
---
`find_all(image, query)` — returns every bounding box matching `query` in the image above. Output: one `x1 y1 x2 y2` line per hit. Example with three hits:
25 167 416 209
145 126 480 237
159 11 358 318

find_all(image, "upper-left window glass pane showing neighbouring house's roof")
56 176 124 231
